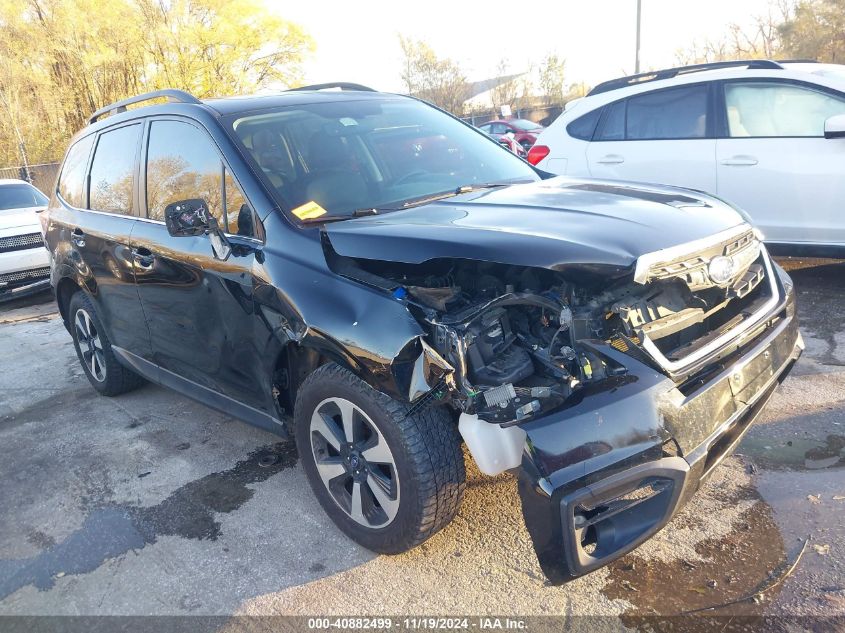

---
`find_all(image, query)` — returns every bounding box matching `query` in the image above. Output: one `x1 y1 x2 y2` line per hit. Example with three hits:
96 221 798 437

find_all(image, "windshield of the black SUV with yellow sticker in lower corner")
230 99 539 220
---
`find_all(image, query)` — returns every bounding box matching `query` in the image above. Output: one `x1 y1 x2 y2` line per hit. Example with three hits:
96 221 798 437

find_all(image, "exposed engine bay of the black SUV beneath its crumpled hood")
330 242 763 426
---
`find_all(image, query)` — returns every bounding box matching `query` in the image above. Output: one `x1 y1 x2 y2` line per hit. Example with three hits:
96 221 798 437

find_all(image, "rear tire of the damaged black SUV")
67 291 146 396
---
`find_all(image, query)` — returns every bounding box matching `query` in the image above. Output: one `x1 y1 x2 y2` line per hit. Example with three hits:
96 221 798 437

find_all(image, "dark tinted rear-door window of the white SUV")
625 84 707 141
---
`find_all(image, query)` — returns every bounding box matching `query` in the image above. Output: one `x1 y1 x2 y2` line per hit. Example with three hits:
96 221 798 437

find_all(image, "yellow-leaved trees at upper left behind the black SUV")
0 0 313 165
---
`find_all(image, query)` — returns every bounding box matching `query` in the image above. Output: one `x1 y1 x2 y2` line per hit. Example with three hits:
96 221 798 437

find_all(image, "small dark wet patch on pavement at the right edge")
738 435 845 470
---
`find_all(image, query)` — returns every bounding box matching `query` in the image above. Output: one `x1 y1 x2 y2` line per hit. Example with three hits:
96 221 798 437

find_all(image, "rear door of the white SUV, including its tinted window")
587 83 716 192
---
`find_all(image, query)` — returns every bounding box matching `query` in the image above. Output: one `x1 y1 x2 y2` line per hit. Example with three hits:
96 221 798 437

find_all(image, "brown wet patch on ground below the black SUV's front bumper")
603 491 792 633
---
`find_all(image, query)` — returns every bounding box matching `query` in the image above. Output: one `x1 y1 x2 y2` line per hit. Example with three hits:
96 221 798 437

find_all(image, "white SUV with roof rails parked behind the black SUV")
528 60 845 256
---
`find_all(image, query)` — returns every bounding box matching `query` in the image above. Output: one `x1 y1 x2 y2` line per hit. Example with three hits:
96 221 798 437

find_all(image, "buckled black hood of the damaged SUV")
325 177 745 270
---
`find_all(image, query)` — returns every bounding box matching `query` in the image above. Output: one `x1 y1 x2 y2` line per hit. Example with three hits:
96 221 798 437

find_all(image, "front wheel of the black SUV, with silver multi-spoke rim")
294 364 466 554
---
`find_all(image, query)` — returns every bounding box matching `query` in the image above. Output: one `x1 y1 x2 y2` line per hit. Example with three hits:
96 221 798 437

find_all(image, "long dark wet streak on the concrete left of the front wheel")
0 442 297 600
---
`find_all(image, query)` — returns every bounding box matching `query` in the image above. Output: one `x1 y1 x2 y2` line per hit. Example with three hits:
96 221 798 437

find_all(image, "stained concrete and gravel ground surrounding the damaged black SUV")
0 260 845 630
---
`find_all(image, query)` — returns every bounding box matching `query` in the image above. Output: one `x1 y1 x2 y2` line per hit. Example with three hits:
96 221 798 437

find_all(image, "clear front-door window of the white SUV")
725 82 845 137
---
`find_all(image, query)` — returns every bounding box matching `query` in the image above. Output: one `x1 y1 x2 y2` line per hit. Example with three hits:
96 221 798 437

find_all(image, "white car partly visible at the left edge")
0 179 50 301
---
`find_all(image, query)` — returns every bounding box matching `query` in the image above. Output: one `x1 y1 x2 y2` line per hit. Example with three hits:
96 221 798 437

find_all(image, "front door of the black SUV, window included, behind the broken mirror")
132 118 272 413
